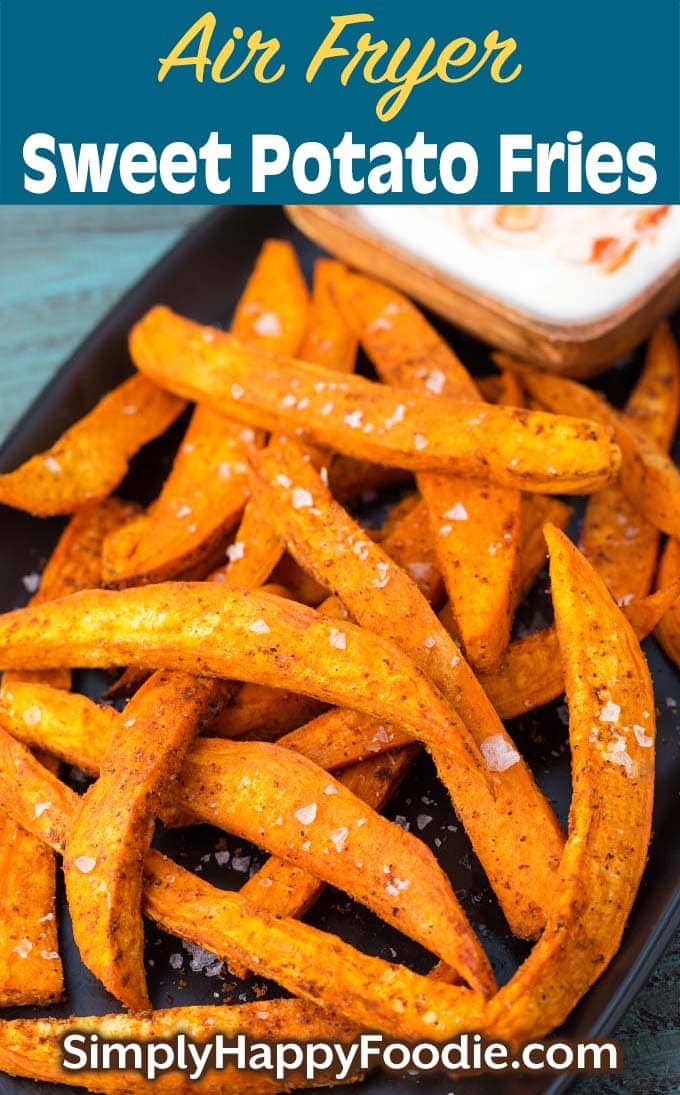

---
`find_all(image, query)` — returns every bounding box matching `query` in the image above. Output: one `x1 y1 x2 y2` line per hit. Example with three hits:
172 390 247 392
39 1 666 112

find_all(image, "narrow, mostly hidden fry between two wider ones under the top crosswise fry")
219 258 357 589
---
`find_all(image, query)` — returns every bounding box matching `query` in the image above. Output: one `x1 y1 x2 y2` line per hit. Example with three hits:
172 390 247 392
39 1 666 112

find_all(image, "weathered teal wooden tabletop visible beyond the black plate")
0 207 680 1095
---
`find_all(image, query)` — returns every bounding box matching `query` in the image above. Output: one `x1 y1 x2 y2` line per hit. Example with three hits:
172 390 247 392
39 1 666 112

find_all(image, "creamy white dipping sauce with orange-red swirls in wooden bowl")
359 205 680 324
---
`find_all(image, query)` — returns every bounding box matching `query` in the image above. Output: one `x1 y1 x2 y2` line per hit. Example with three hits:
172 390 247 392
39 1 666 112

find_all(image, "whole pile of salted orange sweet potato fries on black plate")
0 240 680 1095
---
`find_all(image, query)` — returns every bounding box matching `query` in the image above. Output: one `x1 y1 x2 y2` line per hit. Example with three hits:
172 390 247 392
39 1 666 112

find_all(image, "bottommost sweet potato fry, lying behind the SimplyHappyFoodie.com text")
0 1000 357 1095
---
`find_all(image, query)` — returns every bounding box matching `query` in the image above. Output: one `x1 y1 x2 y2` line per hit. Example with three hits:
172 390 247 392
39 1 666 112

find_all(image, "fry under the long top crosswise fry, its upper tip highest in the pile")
107 240 308 587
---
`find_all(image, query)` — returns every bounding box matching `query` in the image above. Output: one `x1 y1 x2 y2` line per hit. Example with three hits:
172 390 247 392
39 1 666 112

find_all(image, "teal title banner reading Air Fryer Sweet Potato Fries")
0 0 680 205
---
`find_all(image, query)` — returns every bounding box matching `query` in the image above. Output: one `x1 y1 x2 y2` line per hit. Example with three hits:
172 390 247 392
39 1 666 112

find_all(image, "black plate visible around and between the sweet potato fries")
0 207 680 1095
